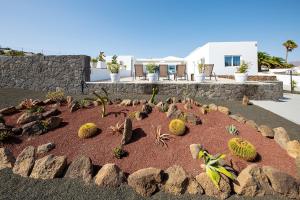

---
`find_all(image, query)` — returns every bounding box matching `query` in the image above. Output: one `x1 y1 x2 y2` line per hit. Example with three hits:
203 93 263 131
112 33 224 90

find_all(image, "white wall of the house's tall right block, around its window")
186 42 258 77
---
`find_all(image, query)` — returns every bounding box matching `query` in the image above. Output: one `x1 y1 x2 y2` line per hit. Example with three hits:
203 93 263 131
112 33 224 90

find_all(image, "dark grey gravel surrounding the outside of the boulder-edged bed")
0 89 300 200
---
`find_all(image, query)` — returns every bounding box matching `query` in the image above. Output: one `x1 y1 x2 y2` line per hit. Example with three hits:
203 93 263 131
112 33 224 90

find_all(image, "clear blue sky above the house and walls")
0 0 300 61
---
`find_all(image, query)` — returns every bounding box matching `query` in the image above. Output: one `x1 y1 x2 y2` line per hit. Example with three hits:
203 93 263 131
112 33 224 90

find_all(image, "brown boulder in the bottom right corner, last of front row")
262 166 300 199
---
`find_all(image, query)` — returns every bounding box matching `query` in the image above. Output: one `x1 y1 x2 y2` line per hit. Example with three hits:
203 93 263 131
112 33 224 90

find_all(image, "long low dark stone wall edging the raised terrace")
87 81 283 100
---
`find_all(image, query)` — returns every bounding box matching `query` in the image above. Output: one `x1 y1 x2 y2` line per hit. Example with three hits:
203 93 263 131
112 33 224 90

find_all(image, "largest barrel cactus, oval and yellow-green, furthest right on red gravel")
228 138 256 161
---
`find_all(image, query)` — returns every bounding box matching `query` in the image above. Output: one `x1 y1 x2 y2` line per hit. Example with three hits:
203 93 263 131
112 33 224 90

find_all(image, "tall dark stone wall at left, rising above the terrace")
0 55 90 93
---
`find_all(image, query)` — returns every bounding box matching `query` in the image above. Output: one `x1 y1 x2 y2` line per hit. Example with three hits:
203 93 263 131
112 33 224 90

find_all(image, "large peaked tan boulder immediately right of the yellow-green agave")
234 164 274 197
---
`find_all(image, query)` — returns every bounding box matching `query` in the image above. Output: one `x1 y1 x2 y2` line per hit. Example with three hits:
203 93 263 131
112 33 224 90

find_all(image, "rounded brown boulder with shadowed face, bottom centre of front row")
128 167 162 197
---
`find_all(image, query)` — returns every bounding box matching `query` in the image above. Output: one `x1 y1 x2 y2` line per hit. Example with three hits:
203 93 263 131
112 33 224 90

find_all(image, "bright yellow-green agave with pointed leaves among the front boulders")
198 150 236 189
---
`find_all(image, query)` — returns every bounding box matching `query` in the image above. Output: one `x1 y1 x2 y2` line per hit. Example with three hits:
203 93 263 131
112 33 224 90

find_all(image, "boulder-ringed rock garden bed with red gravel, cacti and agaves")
0 88 300 199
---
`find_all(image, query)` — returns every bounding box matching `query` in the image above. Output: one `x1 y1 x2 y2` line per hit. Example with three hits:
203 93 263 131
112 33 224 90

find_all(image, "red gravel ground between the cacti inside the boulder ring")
4 105 296 176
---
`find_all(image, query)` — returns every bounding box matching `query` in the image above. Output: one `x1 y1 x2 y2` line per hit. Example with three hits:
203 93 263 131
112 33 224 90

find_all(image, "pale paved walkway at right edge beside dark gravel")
251 93 300 124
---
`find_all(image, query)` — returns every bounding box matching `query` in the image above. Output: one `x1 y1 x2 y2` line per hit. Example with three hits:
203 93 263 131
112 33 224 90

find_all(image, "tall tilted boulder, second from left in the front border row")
13 146 35 177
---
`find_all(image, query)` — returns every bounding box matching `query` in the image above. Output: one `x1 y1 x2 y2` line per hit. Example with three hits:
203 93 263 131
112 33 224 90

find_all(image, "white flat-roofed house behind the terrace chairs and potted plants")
91 41 258 81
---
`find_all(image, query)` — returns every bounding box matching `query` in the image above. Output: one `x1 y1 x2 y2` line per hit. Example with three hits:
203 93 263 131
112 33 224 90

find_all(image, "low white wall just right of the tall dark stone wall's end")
91 68 131 81
